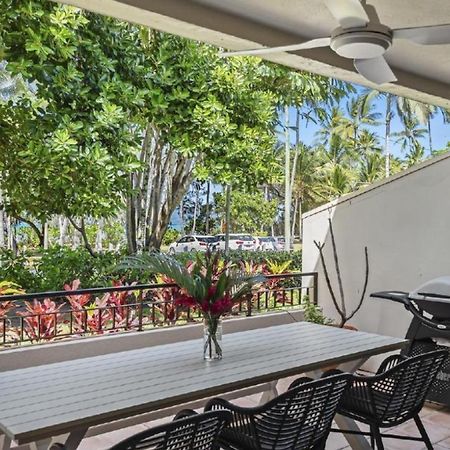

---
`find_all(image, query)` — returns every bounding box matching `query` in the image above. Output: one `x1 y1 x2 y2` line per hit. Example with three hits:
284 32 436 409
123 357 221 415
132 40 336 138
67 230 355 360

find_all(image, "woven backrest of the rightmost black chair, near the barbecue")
370 350 448 423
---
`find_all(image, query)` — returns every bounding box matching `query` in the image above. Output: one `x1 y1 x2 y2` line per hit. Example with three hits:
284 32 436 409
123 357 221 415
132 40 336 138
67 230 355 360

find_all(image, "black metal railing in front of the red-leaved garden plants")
0 272 317 347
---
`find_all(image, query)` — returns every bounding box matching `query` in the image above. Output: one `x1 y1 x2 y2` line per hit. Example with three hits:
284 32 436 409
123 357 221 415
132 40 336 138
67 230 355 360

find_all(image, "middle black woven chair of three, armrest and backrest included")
205 374 351 450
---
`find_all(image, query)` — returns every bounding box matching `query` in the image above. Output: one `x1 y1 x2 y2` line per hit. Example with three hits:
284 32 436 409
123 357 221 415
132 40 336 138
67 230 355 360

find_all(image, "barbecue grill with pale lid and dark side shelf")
370 276 450 406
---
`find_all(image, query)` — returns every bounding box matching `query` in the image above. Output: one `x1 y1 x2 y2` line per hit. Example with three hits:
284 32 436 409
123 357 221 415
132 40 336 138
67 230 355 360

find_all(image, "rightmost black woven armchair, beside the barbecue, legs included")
332 350 448 450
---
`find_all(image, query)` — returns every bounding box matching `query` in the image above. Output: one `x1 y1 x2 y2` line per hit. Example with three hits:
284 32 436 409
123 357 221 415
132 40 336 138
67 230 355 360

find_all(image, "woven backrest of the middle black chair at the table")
251 374 351 450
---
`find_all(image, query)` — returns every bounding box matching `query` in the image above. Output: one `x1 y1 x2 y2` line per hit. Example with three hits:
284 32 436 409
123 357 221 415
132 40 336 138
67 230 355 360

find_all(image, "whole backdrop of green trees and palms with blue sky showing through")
0 0 449 257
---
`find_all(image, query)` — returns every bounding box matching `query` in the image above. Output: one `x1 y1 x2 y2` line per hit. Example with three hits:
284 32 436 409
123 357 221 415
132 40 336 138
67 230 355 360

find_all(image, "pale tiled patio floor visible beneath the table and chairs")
80 379 450 450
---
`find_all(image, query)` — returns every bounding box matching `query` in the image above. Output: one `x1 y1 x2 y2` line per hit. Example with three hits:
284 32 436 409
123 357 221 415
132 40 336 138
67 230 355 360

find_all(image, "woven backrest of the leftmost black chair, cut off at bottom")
110 411 232 450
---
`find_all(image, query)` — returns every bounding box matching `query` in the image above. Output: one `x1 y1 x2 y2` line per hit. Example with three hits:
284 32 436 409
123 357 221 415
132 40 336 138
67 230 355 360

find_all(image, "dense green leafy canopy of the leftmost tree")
0 0 145 253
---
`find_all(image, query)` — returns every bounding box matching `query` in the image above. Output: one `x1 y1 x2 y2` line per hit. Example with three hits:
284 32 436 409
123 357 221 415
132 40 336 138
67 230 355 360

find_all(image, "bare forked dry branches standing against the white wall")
314 219 369 328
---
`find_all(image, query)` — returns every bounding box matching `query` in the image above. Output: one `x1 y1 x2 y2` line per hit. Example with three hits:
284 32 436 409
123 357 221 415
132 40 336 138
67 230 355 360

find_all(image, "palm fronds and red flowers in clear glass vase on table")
123 251 265 360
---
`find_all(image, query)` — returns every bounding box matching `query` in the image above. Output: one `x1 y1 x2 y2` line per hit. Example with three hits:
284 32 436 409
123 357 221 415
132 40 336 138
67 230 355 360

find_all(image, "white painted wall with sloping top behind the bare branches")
303 153 450 369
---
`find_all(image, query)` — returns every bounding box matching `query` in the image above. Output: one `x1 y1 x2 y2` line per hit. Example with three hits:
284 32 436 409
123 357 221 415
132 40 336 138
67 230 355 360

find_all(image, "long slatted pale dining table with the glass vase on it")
0 322 407 450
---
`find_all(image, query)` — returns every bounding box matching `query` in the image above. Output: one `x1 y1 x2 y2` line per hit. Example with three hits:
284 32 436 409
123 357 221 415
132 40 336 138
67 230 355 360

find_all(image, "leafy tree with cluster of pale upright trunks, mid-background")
127 34 282 252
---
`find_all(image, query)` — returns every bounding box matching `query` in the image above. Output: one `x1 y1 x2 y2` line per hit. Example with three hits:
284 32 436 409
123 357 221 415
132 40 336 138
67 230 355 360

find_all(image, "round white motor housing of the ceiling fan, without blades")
330 26 392 59
